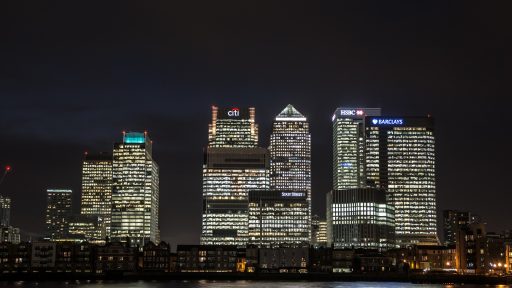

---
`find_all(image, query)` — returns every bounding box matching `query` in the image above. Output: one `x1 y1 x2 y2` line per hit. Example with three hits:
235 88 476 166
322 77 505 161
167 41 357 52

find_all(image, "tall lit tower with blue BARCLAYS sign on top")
365 117 439 246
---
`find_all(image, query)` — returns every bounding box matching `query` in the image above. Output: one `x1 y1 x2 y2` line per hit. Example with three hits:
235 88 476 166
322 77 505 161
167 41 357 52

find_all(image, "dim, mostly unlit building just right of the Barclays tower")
443 210 481 245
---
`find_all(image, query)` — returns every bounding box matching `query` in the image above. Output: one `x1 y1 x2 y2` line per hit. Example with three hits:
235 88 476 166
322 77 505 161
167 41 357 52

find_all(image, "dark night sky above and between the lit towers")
0 1 512 245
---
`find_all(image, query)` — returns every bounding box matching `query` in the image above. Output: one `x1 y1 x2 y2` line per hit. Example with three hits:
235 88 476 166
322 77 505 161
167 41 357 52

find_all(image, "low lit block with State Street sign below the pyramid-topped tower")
249 190 310 247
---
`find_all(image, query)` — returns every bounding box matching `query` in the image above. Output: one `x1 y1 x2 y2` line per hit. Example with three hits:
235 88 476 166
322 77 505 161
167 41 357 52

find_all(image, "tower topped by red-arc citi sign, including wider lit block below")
201 106 270 246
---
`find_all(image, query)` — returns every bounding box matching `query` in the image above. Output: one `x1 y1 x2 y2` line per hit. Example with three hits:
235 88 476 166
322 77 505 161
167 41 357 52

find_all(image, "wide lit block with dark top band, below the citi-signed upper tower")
201 147 269 246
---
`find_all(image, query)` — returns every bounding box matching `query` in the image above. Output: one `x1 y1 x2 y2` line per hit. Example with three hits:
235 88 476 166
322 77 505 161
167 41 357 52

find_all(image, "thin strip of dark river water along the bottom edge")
0 280 511 288
